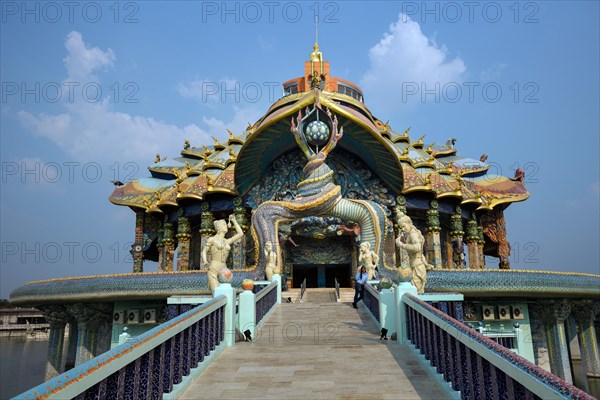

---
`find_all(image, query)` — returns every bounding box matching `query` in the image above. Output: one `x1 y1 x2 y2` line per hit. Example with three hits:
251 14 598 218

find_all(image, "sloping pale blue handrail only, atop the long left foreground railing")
15 296 227 399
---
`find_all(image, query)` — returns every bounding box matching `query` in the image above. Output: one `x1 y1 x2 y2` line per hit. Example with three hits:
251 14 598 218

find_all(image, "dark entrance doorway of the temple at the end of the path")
293 264 352 288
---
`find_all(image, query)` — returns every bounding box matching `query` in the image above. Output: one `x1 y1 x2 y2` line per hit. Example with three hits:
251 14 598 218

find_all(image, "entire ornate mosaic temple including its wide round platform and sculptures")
10 44 600 393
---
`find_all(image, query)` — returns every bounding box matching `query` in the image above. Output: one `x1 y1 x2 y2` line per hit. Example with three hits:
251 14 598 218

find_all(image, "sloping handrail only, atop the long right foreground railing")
402 293 593 399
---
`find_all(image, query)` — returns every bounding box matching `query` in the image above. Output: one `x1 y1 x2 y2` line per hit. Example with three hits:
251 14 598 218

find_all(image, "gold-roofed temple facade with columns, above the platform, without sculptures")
110 46 529 287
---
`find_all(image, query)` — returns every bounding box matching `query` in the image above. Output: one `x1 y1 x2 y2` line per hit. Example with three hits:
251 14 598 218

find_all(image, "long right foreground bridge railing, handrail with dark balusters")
400 293 593 399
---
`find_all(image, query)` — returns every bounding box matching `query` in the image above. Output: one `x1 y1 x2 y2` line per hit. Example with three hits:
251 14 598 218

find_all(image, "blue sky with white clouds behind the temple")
0 1 600 298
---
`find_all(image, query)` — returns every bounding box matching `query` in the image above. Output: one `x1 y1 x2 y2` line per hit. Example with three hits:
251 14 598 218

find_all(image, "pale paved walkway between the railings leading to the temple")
181 302 449 400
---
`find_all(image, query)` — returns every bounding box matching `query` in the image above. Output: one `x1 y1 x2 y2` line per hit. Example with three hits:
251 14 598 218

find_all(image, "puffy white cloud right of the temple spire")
361 14 466 106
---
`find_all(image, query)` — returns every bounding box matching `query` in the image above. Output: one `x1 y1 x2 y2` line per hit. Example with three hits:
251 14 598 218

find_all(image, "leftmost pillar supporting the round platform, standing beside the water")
40 305 69 380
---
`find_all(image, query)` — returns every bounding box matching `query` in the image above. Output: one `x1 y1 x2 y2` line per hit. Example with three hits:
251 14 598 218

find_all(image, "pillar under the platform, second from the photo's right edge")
541 301 573 383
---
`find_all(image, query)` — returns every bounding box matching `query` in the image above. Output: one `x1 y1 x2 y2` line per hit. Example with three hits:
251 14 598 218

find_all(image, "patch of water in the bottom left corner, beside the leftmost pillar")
0 338 48 400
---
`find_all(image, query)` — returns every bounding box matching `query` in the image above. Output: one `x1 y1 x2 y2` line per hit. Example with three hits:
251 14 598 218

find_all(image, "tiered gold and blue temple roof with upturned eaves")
109 77 529 213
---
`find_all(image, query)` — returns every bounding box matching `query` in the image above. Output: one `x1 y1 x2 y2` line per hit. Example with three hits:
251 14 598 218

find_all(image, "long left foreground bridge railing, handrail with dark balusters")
16 296 229 399
